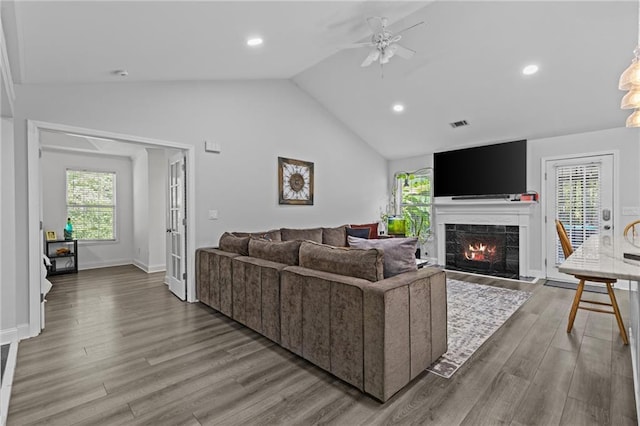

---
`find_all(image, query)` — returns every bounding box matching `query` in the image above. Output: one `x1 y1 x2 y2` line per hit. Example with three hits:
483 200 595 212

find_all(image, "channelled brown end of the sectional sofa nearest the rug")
364 268 447 401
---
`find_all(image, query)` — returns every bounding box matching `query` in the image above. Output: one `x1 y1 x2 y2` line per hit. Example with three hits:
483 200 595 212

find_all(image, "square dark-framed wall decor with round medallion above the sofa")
278 157 313 205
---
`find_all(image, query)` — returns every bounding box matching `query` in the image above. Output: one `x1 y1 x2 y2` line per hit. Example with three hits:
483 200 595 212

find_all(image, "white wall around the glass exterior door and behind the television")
388 127 640 273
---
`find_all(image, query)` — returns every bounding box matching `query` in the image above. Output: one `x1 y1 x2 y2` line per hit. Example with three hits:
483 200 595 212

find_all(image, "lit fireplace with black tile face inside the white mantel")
445 224 520 279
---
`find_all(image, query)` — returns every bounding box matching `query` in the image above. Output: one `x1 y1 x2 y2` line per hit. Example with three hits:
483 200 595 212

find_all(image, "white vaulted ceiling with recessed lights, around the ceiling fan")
2 0 639 159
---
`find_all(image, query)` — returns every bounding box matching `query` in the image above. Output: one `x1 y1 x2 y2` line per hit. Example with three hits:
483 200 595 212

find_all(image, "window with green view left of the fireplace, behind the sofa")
396 169 432 244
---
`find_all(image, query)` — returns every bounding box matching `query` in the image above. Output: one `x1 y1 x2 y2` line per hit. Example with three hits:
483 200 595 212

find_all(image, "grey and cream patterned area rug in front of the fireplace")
427 278 531 379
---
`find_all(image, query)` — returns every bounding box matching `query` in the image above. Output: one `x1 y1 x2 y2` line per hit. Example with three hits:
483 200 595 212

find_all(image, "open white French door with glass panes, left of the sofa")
167 152 187 300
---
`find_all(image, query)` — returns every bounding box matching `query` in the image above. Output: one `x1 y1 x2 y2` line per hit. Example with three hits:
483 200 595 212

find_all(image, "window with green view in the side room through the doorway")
67 169 116 240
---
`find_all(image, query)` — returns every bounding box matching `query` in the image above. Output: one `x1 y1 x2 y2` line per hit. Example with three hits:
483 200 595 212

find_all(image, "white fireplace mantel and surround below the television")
434 200 537 277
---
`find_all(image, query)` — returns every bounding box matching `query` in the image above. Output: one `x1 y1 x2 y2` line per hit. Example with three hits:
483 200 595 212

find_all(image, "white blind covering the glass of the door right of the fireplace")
556 163 600 264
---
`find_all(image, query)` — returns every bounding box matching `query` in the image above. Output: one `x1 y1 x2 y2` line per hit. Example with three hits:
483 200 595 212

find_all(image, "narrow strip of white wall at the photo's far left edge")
0 118 18 344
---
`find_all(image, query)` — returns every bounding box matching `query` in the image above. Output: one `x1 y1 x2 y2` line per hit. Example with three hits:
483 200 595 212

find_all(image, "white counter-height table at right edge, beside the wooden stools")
558 235 640 420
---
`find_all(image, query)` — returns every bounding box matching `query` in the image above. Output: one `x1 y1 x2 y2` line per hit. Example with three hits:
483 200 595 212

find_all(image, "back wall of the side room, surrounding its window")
41 150 133 269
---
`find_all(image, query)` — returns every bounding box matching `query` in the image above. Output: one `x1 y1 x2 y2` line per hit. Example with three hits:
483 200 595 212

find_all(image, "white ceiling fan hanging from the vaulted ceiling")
344 16 424 67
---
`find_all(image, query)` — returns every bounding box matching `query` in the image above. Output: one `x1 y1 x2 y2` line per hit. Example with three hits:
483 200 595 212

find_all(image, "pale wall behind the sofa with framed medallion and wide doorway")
15 80 387 332
